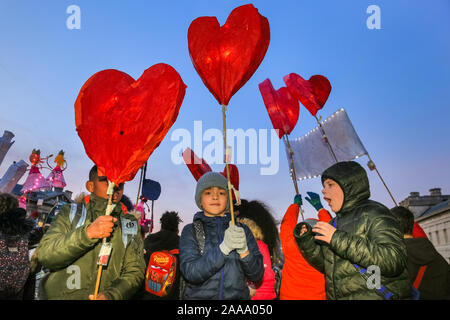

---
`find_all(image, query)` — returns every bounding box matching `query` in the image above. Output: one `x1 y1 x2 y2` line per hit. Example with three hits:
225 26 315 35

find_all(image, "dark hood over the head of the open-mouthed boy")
322 161 370 214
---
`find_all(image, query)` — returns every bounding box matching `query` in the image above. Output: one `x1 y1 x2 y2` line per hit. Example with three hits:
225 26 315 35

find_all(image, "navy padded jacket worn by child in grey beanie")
180 212 264 300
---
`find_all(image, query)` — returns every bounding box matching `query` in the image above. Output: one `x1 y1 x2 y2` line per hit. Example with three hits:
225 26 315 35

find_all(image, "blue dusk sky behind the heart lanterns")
0 0 450 229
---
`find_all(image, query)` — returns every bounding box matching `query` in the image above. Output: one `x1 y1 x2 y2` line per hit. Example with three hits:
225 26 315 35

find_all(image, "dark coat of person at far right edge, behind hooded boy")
405 238 450 300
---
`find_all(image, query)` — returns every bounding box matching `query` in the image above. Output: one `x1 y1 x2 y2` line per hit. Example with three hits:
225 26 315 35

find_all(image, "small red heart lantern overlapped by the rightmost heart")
259 79 300 138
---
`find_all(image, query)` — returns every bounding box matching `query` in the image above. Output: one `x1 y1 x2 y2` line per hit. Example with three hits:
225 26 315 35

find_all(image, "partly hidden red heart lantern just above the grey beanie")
183 148 239 192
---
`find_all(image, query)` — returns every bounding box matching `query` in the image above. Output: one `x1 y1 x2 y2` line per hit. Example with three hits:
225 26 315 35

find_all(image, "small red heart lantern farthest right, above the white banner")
284 73 331 116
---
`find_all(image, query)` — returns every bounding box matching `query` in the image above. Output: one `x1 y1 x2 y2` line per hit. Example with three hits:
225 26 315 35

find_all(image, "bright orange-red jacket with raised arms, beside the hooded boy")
280 203 331 300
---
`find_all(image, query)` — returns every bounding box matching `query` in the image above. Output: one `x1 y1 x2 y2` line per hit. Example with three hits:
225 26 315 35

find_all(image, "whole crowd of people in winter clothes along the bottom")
0 161 450 300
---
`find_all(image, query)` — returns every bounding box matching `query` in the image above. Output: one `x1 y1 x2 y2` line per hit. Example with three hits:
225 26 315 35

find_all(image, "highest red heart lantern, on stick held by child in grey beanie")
188 4 270 105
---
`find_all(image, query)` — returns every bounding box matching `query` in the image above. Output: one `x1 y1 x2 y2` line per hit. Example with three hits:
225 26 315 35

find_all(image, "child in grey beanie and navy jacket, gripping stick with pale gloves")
180 172 264 300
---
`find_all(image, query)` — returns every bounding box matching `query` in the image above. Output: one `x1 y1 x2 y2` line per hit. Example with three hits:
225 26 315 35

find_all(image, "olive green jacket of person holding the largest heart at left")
37 194 145 300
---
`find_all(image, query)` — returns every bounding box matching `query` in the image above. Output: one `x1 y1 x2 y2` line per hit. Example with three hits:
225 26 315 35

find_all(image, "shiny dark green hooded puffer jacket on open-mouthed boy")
294 161 411 300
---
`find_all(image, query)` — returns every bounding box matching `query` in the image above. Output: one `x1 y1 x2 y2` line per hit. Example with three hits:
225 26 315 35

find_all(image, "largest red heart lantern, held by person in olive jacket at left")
75 63 186 185
